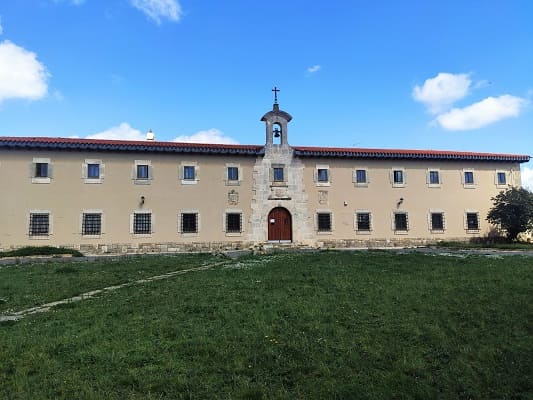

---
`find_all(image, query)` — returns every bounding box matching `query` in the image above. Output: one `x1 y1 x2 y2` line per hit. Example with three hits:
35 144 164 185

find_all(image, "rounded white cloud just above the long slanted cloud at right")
413 72 472 114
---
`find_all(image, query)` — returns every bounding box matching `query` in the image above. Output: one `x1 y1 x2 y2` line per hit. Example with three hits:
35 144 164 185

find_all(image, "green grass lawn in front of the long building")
0 251 533 399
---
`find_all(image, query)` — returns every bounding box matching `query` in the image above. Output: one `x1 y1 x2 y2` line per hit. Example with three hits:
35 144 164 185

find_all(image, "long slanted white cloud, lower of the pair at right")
437 94 528 131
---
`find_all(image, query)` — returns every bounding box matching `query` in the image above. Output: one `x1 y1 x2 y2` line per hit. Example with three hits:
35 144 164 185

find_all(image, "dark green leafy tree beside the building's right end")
487 187 533 241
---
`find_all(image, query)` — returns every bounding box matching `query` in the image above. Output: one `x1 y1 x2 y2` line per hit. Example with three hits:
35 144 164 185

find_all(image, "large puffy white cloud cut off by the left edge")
0 40 50 103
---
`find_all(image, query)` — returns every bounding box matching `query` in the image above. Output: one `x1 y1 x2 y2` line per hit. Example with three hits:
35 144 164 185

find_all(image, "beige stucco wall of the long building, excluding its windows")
0 150 520 253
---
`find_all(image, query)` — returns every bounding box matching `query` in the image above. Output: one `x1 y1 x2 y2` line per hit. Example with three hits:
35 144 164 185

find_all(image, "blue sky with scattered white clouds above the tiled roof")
0 0 533 189
